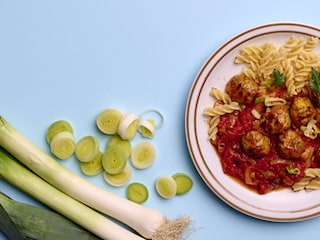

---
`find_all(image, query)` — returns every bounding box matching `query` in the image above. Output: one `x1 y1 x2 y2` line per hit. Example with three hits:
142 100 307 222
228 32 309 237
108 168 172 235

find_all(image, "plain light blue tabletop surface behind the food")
0 0 320 240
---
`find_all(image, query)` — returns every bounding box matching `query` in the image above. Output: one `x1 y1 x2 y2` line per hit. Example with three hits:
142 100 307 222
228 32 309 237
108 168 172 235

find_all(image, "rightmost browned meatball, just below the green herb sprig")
290 97 316 127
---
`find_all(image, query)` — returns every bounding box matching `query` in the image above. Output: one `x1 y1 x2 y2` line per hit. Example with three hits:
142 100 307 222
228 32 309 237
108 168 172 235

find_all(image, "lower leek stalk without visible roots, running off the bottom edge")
0 149 143 240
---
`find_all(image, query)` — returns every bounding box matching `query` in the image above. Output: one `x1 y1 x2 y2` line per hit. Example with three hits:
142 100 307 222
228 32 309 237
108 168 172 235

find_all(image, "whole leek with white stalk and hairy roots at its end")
0 116 191 240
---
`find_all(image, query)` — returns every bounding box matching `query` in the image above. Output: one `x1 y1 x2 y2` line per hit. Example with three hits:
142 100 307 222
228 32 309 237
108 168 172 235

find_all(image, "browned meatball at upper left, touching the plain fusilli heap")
226 74 258 104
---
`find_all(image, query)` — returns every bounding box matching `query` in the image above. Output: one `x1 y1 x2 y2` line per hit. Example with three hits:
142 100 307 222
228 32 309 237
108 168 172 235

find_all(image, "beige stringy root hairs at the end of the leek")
152 216 192 240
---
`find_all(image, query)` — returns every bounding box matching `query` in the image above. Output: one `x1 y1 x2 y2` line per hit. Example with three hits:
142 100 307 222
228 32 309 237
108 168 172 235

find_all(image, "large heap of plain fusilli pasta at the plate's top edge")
235 36 320 96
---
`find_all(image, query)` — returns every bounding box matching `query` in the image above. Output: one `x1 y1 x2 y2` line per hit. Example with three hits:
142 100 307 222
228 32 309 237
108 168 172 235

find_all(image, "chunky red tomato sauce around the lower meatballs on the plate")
211 104 320 194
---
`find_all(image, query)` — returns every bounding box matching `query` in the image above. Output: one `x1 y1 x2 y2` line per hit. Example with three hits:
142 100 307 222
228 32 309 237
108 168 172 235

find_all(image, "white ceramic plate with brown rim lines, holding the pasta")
185 23 320 222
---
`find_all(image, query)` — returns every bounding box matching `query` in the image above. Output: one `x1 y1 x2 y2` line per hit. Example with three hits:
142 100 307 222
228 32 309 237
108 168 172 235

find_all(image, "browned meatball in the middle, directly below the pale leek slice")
264 105 291 134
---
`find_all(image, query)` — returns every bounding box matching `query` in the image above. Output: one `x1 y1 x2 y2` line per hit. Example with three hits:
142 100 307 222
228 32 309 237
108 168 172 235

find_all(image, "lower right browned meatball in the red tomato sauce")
278 129 304 159
